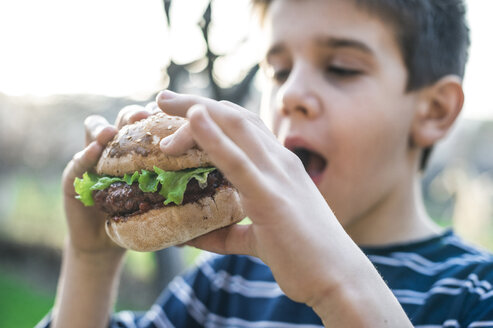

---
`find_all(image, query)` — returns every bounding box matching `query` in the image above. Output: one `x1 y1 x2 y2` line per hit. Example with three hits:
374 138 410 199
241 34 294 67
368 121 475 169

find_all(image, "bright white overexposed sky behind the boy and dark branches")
0 0 493 119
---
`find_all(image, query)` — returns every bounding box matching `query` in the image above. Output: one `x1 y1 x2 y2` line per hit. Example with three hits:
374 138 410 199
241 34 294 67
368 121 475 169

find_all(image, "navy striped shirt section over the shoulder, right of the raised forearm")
367 231 493 326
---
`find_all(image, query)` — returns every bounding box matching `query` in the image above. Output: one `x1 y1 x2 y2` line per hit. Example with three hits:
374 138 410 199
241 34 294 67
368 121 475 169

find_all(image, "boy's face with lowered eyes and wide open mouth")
265 0 417 227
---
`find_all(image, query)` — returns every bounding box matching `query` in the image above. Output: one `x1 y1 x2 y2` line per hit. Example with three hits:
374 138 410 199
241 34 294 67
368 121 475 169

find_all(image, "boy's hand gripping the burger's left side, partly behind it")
62 106 150 255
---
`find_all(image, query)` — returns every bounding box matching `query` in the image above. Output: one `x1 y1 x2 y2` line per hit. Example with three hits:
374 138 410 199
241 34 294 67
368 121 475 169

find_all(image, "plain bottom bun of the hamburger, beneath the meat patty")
106 187 245 252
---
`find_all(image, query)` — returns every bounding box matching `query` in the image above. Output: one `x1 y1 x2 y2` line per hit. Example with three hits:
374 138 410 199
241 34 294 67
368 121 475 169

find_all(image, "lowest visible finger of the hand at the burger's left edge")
63 141 103 195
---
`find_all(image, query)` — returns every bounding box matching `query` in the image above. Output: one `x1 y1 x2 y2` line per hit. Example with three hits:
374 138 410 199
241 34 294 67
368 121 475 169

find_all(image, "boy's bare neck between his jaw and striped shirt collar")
345 176 440 246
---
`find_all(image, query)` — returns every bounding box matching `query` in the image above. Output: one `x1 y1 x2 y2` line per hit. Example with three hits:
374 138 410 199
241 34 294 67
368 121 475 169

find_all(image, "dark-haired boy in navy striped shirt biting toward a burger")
37 0 493 327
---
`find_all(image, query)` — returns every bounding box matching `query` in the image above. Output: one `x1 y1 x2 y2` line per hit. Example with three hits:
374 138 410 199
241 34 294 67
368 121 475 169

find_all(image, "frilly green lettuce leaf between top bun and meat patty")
74 166 216 206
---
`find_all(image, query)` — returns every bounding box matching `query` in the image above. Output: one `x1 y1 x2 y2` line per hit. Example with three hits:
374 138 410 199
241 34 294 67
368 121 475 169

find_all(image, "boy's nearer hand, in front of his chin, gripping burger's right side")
157 91 357 305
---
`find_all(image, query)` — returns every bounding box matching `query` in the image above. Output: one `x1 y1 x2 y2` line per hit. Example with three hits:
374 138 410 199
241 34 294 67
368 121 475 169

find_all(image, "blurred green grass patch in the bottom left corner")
0 272 54 328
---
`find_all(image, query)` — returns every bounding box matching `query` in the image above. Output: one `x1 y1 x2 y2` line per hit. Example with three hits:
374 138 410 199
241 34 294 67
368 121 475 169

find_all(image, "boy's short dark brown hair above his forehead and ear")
252 0 470 170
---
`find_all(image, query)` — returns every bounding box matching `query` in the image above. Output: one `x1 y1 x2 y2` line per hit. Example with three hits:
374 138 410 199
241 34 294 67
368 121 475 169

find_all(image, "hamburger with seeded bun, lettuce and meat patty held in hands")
74 113 244 251
